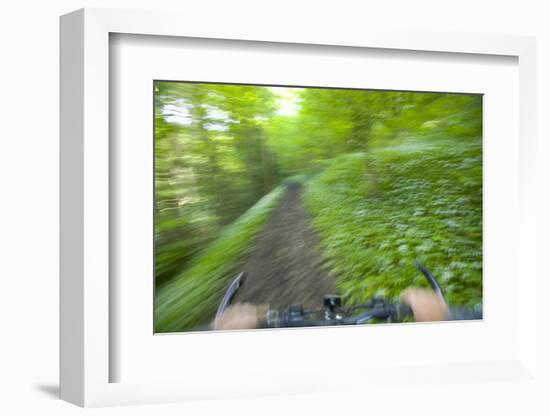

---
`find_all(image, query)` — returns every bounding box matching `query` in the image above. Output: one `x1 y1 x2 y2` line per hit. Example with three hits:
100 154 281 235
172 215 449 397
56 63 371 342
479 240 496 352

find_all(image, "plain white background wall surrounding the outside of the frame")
0 0 550 415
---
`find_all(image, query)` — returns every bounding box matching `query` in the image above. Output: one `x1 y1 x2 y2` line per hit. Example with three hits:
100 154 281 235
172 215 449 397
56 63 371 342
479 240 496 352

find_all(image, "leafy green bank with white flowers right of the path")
305 137 482 305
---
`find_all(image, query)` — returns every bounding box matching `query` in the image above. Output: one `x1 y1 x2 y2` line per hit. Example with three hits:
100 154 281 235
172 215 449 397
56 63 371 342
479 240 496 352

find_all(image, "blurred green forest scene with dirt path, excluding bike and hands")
154 81 482 332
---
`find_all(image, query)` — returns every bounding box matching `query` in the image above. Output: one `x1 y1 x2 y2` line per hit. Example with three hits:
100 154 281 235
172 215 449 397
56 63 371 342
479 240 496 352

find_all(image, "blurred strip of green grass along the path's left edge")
155 187 284 332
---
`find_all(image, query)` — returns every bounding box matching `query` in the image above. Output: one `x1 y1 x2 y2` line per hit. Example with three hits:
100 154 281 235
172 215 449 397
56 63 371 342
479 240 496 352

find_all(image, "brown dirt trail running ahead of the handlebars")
234 185 335 310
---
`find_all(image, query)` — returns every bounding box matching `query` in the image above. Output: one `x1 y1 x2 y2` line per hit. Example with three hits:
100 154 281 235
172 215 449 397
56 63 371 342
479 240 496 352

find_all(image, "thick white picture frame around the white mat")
60 9 537 407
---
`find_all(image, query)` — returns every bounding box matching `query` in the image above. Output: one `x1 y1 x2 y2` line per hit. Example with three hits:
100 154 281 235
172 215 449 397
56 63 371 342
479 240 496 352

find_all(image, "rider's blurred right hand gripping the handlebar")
401 287 449 322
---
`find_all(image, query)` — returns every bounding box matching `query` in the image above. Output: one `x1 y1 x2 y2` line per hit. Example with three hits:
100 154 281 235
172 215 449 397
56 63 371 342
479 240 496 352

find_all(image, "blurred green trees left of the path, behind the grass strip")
155 82 278 288
